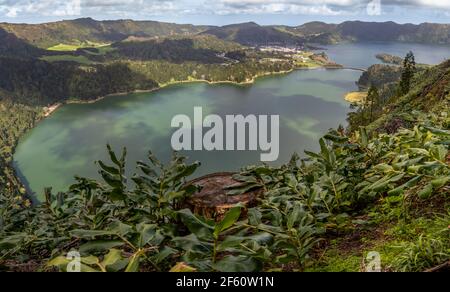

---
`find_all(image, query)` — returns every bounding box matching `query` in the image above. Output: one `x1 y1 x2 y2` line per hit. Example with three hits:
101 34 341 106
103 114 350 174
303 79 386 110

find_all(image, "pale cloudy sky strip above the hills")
0 0 450 25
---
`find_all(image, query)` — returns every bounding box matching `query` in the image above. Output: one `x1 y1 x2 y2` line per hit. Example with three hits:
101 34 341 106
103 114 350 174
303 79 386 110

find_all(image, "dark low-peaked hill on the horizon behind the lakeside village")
203 22 303 46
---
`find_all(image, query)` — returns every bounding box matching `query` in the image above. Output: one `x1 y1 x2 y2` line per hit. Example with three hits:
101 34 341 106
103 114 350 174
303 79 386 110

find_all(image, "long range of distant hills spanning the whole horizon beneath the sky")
0 18 450 49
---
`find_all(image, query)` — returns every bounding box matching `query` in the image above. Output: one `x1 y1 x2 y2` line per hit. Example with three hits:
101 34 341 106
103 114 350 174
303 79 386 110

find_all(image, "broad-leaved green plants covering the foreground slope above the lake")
0 110 450 272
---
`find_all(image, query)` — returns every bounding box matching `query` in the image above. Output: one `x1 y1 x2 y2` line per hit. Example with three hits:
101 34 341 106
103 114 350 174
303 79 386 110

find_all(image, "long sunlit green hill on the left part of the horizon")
0 18 210 48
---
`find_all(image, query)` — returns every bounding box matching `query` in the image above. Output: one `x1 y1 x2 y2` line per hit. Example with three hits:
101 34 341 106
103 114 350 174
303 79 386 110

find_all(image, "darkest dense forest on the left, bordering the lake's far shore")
0 57 157 105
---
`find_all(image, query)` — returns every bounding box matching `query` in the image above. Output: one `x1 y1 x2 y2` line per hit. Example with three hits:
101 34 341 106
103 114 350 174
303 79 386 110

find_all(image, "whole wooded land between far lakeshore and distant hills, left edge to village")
0 33 306 106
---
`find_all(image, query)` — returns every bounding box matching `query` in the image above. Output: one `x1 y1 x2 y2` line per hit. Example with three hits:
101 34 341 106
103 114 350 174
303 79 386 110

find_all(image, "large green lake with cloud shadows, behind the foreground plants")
14 69 361 198
